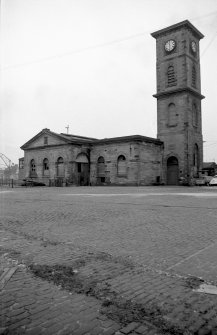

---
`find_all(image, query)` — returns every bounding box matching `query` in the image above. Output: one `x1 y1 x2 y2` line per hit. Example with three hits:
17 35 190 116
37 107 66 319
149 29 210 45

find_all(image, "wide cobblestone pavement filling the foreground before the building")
0 187 217 335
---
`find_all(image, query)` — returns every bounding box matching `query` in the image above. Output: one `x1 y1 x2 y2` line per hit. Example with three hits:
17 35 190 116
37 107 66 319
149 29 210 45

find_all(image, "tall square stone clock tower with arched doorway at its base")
151 20 204 185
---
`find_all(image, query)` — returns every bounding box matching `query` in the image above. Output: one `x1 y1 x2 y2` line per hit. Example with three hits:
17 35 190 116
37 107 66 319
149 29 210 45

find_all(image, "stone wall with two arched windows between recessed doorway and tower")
90 142 162 185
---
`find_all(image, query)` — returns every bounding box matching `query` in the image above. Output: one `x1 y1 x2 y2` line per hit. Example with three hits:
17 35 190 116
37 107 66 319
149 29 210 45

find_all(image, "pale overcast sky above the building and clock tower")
0 0 217 167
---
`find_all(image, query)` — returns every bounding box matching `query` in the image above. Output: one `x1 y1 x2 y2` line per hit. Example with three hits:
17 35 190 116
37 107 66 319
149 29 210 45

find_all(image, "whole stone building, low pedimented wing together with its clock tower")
19 20 204 185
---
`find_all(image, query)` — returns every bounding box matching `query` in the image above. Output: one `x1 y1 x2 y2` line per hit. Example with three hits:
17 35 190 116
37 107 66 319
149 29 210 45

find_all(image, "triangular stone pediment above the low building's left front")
21 128 71 150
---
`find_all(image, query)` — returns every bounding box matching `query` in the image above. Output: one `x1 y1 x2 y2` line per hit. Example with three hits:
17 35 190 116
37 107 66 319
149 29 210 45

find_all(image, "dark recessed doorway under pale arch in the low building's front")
76 153 90 186
